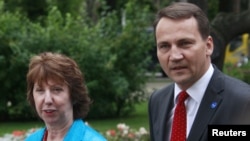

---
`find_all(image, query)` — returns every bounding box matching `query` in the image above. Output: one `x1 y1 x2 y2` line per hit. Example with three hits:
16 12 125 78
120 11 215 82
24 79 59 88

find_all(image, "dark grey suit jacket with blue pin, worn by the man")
148 66 250 141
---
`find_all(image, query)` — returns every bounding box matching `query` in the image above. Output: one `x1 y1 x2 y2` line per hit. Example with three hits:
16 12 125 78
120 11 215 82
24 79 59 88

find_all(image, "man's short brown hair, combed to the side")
154 2 210 39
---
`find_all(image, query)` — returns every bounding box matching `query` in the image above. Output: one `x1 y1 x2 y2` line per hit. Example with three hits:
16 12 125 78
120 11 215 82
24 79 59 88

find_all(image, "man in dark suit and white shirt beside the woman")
148 2 250 141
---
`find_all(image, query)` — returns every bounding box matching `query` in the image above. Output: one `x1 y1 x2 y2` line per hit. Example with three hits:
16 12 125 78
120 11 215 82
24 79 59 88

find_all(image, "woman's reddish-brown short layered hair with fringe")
26 52 91 119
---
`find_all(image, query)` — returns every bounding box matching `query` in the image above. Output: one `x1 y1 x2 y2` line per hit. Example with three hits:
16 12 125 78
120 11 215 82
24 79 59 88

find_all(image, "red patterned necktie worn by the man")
171 91 188 141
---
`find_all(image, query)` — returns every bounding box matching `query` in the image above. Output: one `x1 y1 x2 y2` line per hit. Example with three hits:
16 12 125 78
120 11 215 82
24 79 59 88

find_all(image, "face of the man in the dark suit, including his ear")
155 17 213 89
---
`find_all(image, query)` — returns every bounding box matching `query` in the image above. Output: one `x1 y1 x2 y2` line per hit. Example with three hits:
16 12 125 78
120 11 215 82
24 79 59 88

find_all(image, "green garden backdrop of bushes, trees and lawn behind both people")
0 0 250 140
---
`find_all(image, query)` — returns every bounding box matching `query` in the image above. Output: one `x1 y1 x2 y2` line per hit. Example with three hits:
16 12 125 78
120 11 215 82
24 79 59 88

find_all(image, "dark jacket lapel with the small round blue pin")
187 67 224 141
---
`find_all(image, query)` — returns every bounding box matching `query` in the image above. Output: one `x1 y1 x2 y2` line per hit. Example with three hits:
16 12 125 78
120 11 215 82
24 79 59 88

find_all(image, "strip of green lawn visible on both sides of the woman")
0 102 149 136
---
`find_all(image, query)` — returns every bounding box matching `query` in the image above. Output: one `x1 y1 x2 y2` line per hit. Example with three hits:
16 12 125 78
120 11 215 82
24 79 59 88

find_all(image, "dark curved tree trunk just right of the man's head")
211 10 250 70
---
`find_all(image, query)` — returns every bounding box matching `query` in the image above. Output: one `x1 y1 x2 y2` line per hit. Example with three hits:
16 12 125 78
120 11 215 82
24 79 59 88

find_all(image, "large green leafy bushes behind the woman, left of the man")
0 0 153 120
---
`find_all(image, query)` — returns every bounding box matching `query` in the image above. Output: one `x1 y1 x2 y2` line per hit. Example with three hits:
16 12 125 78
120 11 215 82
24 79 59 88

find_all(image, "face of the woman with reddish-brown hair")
33 80 73 126
